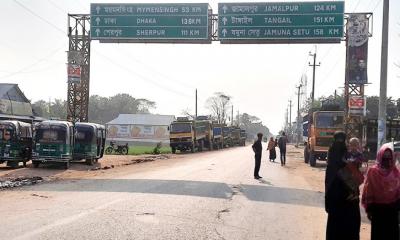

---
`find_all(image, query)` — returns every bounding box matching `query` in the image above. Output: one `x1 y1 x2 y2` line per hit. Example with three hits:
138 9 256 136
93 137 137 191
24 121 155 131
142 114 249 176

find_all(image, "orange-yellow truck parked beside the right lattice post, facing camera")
304 111 344 167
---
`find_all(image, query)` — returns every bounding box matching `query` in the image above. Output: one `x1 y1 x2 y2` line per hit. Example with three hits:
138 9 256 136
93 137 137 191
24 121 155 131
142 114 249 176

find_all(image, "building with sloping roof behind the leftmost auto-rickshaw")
0 83 43 122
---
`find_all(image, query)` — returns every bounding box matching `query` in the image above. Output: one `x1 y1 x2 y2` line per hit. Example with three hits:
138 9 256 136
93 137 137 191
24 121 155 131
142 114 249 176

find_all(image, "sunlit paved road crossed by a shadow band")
0 147 368 240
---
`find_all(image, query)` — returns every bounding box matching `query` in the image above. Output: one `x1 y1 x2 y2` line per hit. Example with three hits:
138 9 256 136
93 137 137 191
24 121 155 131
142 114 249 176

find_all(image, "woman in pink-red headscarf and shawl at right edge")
362 145 400 240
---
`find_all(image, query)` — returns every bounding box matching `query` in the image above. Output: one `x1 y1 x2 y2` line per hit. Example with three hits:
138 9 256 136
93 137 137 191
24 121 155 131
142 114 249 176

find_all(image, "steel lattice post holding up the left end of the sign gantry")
67 14 90 122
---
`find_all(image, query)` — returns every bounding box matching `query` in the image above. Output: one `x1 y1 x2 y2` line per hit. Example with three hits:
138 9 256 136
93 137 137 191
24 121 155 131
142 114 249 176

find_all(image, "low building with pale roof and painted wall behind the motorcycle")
106 114 175 145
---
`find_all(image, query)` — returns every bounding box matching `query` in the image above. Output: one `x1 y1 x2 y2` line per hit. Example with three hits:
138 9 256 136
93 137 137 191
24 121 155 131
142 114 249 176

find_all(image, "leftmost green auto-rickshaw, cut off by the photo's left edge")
0 120 32 168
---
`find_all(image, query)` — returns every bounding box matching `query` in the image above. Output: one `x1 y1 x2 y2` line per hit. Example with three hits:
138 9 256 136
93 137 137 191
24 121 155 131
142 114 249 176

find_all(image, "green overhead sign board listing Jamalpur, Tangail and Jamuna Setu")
218 1 344 43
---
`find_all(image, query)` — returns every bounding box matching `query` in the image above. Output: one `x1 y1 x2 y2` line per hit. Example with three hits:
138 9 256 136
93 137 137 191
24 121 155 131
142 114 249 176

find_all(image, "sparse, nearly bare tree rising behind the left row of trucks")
206 92 231 123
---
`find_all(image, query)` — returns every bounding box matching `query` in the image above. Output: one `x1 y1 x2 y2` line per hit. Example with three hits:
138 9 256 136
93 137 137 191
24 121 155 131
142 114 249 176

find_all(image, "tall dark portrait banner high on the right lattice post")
346 14 369 85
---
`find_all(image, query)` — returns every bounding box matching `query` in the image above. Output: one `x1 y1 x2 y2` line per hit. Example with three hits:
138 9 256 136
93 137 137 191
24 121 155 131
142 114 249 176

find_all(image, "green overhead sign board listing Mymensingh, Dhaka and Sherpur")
90 3 210 42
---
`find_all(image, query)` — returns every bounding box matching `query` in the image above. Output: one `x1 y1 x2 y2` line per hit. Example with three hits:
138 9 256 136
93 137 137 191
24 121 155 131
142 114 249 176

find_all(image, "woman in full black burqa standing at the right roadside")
325 132 361 240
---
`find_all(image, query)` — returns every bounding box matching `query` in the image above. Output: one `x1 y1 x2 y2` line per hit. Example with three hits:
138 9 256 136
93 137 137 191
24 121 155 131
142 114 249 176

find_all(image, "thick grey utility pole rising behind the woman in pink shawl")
377 0 389 150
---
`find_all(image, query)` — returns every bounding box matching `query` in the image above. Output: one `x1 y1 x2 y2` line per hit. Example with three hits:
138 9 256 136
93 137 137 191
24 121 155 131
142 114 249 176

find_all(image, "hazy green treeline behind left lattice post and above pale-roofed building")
32 94 156 124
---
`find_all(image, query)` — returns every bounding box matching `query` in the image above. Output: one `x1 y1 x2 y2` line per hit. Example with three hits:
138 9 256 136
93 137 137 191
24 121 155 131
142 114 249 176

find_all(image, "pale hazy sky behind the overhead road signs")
0 0 400 133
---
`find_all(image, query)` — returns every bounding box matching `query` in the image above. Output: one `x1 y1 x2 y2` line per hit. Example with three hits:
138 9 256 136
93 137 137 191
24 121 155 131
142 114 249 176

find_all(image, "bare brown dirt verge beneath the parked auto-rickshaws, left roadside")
0 154 177 187
